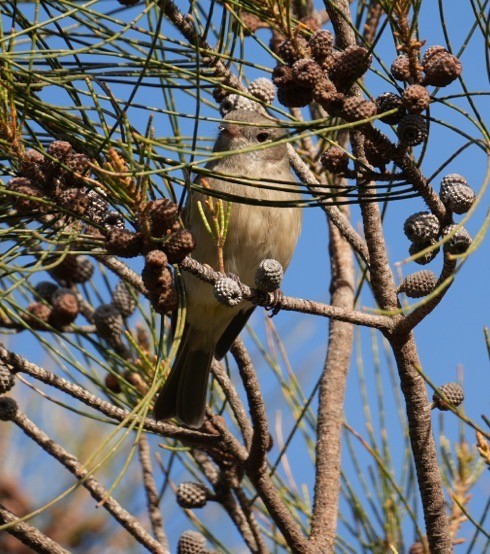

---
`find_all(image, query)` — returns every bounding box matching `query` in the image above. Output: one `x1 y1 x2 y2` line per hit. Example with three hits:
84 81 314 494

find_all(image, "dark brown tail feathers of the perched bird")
153 329 214 429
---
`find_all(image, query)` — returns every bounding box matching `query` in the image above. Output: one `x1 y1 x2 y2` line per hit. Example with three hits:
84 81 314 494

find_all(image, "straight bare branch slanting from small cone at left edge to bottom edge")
6 402 168 554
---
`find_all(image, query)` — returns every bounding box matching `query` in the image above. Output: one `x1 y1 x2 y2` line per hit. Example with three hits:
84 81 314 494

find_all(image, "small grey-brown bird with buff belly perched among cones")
153 110 301 429
